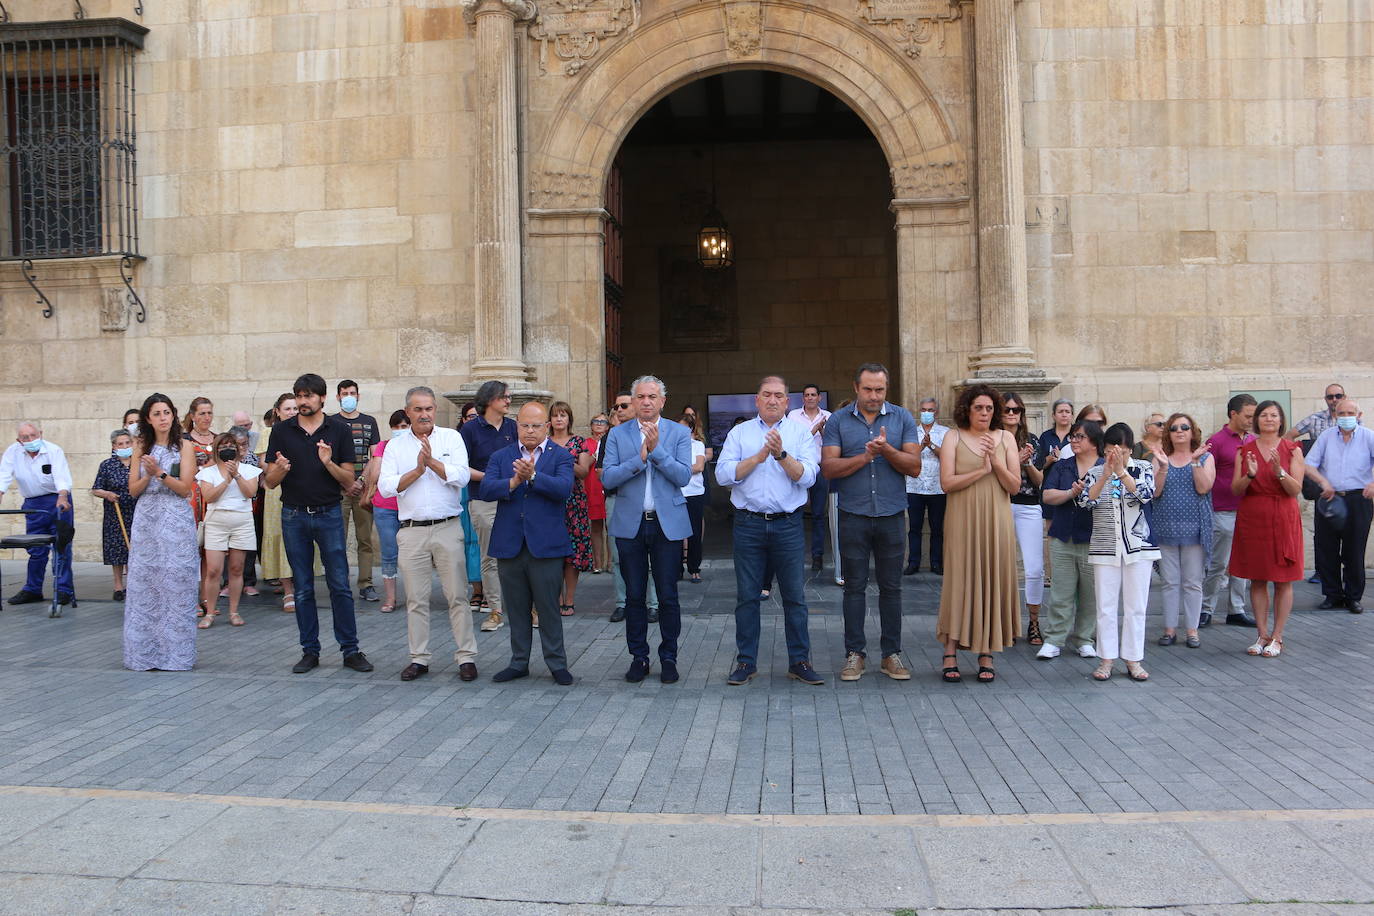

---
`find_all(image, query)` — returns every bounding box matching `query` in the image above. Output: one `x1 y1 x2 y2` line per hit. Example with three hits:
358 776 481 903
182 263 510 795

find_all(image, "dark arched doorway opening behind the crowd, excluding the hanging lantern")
606 70 900 426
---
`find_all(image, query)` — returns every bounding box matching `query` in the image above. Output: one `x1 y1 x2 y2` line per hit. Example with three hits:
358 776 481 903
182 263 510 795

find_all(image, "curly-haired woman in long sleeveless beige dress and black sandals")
936 385 1021 684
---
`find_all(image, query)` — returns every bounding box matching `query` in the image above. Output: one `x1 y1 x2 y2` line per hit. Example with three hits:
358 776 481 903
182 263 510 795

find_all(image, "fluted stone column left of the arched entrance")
463 0 534 382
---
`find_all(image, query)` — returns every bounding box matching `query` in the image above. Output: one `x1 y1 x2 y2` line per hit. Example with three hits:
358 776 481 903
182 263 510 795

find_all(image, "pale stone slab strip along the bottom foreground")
0 787 1374 916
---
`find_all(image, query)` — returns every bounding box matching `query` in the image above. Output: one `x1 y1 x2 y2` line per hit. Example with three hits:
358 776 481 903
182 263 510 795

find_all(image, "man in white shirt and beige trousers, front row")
376 386 477 681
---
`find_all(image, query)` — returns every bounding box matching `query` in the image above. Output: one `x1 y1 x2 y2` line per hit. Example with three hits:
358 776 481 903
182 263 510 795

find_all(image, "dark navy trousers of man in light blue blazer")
616 519 683 662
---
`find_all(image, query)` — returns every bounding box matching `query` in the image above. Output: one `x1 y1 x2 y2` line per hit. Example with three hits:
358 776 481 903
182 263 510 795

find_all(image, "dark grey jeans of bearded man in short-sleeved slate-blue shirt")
840 511 907 656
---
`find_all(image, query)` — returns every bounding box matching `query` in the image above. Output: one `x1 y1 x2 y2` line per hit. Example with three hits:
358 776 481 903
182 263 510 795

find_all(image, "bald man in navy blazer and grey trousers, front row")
480 402 573 687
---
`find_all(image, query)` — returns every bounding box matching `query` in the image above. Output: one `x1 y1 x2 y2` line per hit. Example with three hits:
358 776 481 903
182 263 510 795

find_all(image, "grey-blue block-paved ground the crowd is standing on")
0 560 1374 814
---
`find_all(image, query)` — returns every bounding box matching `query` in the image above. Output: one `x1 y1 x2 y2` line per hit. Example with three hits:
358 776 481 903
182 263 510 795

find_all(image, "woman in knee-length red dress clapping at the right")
1227 401 1305 658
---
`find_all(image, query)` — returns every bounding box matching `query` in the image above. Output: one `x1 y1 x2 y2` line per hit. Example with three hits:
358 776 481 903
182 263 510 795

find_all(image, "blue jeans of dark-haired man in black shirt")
282 503 359 658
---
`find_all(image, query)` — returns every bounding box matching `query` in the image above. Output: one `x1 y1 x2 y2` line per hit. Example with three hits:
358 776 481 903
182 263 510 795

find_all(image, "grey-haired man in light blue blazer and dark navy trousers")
602 375 691 684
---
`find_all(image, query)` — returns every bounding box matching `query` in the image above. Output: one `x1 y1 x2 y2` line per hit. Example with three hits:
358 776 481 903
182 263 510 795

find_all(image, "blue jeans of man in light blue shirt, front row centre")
735 509 811 666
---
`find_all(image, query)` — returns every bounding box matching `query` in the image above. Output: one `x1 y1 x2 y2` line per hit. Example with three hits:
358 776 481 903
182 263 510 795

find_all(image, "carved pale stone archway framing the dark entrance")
525 0 978 420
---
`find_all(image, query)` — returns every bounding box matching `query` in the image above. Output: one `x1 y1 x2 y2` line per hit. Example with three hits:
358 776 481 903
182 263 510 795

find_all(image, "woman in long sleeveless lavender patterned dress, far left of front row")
124 394 201 672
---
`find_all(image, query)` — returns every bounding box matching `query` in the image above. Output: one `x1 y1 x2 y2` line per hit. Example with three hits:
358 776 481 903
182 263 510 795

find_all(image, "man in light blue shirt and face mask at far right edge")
1307 398 1374 614
